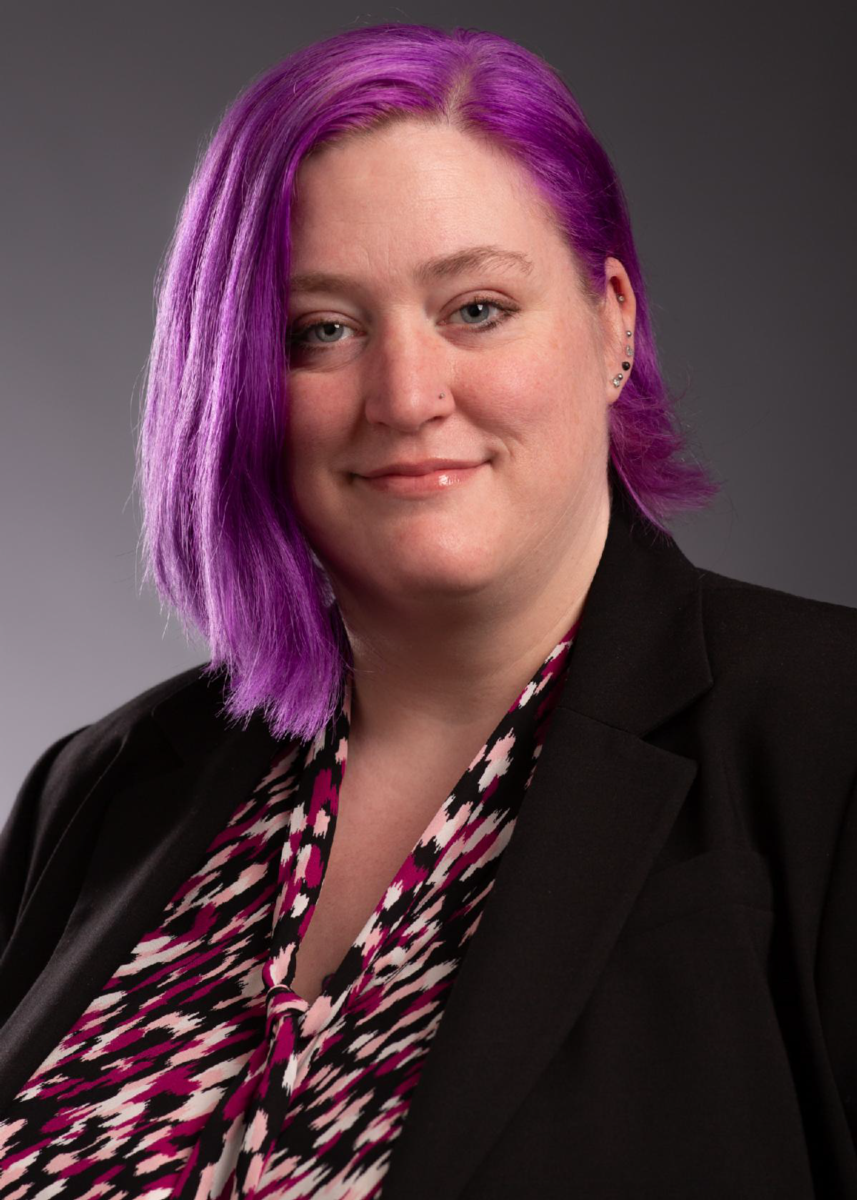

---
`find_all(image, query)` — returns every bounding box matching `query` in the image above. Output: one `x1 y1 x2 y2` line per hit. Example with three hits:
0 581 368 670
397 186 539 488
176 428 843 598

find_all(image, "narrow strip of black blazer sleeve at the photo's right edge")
815 778 857 1148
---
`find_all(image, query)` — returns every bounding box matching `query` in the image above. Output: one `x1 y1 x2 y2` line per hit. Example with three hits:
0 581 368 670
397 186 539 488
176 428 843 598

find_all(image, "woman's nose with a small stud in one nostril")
364 316 455 433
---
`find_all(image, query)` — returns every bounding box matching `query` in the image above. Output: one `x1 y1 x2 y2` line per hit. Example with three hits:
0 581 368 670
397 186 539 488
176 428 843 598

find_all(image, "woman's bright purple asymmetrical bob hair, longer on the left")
136 24 720 739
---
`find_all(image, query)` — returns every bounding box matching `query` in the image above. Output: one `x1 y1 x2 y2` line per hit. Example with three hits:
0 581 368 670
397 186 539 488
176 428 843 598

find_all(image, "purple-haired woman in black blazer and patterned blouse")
0 18 857 1200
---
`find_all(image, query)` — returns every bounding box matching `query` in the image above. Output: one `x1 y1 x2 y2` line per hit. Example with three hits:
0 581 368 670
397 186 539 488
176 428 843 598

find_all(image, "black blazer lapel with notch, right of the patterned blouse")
376 493 713 1200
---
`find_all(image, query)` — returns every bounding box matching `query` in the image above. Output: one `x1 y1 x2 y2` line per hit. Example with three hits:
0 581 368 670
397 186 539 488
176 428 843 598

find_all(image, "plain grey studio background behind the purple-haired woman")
0 0 857 822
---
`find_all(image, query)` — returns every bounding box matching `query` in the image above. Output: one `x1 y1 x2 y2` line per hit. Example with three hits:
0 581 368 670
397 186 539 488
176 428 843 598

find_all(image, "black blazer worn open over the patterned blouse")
0 493 857 1200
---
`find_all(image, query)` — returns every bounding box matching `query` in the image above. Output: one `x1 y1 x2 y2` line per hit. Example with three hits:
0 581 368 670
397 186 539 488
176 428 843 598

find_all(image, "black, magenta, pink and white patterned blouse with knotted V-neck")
0 620 580 1200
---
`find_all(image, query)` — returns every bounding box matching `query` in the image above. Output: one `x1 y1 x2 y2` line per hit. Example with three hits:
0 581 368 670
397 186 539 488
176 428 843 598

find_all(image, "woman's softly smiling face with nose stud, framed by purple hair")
286 121 630 602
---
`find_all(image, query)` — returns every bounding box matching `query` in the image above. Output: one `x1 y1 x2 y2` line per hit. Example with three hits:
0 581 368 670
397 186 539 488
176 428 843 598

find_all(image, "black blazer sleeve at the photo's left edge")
0 725 89 959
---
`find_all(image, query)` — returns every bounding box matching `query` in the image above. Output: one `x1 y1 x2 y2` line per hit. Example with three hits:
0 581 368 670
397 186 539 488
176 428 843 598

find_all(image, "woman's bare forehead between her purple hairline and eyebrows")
290 121 561 283
